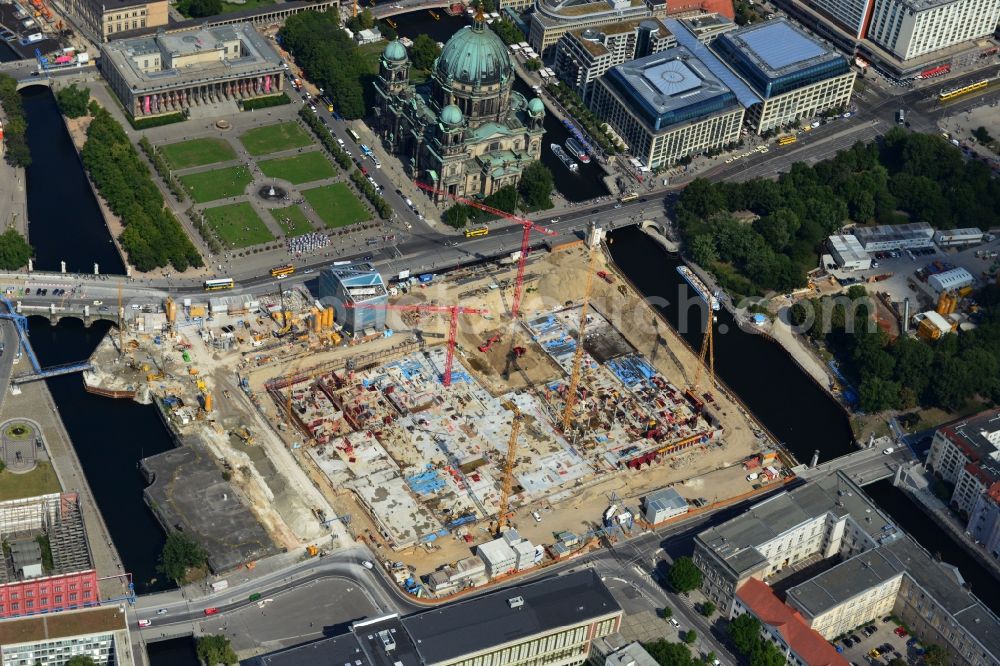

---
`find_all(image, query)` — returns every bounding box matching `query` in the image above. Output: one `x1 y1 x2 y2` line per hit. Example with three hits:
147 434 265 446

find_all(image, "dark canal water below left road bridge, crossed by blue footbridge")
29 317 174 594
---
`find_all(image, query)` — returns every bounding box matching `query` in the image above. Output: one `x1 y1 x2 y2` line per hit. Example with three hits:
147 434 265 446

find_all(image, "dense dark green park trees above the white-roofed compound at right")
676 128 1000 295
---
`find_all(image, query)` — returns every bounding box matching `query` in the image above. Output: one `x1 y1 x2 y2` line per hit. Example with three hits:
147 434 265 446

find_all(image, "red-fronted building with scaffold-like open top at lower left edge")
0 493 100 618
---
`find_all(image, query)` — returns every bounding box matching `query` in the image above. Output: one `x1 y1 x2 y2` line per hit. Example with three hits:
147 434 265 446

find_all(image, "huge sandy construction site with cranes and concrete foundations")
85 224 788 593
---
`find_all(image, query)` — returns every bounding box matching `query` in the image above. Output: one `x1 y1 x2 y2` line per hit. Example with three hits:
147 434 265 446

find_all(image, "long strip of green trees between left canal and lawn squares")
80 108 202 271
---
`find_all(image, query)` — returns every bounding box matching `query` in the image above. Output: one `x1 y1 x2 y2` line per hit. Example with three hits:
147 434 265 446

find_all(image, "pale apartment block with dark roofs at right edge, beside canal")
927 410 1000 559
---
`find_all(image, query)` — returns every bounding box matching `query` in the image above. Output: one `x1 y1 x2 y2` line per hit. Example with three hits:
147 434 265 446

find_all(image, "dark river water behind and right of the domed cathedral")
393 9 608 203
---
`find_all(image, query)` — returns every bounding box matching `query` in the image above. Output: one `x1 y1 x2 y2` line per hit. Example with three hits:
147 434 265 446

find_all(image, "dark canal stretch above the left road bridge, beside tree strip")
22 86 125 275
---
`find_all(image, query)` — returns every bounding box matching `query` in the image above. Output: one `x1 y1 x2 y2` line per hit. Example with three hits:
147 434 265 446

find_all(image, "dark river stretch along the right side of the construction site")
610 227 854 462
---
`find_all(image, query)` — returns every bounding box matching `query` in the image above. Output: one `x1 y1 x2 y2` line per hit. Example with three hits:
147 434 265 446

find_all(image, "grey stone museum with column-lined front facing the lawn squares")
101 23 285 118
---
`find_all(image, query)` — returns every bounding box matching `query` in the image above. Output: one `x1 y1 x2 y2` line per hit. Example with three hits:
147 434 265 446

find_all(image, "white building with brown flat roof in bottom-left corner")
0 606 135 666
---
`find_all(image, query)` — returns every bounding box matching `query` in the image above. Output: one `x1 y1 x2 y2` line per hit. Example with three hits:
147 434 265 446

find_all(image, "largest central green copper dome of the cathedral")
437 22 514 85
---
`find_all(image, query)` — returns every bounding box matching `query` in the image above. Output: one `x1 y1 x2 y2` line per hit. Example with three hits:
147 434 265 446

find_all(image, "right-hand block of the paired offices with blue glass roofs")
711 18 855 134
